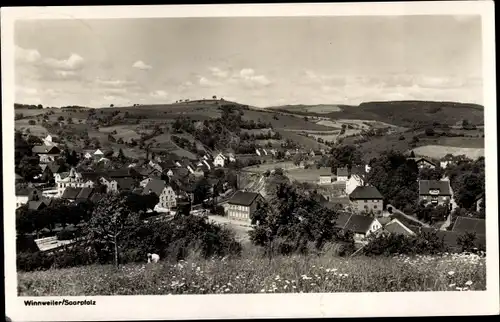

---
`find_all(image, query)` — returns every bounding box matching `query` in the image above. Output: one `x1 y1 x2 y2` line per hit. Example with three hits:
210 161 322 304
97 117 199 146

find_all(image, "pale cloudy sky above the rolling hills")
15 16 482 107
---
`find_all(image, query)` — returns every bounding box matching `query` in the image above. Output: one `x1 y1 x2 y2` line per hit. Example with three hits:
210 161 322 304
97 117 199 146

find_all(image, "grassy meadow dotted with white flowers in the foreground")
18 251 486 296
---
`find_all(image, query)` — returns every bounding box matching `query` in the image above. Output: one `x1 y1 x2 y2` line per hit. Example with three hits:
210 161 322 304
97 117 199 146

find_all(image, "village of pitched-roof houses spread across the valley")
16 130 485 252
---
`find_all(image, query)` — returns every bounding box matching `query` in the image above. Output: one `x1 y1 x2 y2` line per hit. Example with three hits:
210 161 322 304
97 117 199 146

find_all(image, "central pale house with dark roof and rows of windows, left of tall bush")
226 191 264 222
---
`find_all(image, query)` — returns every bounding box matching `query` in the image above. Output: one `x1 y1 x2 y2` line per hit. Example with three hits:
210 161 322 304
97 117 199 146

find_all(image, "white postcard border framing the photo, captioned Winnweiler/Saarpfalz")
1 1 500 321
